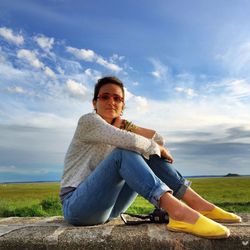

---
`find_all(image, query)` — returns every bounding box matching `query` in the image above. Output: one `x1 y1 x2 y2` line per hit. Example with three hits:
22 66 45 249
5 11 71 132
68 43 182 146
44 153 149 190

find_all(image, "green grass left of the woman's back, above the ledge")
0 182 62 217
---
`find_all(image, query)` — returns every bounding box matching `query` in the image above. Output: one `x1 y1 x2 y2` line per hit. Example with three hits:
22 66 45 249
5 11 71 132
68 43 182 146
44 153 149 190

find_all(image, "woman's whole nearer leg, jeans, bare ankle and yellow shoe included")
63 149 230 238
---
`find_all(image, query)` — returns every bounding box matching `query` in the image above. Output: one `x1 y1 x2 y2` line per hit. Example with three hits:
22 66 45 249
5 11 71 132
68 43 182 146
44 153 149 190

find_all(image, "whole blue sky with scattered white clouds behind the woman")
0 0 250 182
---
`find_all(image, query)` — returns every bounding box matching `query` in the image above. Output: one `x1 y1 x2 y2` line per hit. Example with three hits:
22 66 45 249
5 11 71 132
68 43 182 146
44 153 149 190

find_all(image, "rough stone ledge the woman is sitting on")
0 214 250 250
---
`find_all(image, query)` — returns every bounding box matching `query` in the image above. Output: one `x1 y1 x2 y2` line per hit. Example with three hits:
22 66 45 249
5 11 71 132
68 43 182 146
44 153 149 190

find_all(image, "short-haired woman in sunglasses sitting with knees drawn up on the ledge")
60 77 241 238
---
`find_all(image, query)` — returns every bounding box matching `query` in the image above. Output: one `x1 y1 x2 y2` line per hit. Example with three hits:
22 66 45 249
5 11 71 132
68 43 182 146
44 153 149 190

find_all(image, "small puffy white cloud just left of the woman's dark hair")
65 79 88 100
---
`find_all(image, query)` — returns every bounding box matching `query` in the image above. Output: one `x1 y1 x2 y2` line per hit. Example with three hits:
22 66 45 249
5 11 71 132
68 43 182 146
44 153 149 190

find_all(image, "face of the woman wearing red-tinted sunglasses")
93 83 124 123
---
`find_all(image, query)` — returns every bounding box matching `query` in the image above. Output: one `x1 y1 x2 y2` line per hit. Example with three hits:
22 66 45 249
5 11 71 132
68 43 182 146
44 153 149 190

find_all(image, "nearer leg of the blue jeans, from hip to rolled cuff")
63 149 171 225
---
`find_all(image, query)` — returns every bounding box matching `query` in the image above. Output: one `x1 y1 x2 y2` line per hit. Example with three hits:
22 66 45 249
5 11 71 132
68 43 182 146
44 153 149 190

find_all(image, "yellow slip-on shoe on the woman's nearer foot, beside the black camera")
167 215 230 239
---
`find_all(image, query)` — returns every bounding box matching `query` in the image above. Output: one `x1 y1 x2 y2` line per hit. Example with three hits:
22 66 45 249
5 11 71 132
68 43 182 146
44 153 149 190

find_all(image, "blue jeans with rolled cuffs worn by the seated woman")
63 148 188 225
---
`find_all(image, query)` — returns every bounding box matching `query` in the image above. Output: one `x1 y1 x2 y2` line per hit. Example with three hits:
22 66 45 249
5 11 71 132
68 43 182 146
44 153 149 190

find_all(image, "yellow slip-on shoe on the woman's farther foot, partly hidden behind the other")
199 207 242 223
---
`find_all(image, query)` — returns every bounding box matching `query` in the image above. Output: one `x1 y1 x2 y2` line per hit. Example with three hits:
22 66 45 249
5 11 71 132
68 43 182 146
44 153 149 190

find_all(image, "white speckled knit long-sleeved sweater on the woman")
61 113 164 188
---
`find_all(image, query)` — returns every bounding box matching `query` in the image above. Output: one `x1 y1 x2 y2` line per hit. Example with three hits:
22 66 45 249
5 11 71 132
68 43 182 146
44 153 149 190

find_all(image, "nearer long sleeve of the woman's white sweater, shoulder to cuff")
76 113 161 158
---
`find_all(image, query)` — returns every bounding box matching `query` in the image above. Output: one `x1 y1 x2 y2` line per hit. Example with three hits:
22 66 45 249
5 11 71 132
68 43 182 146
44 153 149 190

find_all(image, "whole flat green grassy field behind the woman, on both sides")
0 177 250 217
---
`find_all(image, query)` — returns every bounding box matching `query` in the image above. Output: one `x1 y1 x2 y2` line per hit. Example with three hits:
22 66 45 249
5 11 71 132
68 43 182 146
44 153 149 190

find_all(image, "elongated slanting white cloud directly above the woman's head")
66 47 122 72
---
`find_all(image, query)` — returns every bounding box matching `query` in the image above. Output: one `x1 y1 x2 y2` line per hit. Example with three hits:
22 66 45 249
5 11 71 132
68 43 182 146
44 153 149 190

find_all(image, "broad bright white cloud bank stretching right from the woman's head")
121 85 250 139
